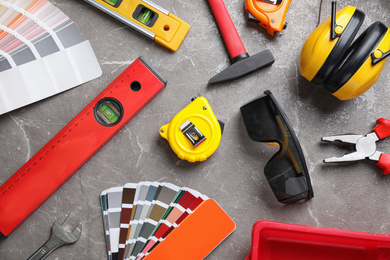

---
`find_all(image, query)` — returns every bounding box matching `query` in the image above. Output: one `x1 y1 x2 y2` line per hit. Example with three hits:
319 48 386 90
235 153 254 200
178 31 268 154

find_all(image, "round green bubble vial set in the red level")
94 97 123 126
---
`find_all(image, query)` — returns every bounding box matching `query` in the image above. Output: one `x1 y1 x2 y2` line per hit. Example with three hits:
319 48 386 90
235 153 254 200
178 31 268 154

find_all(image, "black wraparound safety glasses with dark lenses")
241 90 313 204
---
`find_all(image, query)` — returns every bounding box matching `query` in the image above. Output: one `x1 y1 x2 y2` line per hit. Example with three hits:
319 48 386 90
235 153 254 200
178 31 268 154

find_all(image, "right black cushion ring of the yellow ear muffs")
324 22 388 93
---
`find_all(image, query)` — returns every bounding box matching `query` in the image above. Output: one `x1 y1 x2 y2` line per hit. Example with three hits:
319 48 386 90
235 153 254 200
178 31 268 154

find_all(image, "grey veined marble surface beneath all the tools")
0 0 390 260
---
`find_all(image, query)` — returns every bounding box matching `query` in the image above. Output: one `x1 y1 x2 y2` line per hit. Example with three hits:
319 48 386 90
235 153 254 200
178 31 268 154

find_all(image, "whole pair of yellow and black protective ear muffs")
299 3 390 100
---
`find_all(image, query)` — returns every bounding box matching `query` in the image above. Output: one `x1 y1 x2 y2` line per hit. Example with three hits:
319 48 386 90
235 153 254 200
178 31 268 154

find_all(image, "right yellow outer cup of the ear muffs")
333 29 390 100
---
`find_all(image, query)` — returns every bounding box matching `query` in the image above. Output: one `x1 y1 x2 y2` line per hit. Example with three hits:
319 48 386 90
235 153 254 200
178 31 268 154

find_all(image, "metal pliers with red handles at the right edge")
321 118 390 175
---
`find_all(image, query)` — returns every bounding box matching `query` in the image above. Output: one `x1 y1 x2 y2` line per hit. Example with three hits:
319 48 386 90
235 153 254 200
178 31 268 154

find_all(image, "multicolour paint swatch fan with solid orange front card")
101 182 235 260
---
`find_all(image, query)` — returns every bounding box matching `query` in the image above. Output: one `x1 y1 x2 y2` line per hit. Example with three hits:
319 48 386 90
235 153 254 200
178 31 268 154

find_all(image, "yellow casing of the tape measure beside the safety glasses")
160 97 222 162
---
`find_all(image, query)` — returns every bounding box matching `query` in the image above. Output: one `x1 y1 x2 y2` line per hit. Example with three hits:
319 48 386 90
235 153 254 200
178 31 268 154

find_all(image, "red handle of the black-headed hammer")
208 0 247 60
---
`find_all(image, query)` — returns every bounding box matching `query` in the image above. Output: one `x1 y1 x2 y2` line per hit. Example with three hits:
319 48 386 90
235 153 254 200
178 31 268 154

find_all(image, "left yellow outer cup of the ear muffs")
299 6 356 81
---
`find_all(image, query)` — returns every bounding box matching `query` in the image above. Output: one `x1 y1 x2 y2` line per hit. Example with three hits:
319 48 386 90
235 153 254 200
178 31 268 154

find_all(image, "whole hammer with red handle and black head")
208 0 275 85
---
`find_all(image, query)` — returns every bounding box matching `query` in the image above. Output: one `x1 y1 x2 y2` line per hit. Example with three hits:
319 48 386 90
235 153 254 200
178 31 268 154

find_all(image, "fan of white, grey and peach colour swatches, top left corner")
0 0 102 114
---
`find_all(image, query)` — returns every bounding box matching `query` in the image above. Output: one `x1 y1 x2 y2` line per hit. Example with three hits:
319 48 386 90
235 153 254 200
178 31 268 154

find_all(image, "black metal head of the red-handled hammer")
209 50 275 85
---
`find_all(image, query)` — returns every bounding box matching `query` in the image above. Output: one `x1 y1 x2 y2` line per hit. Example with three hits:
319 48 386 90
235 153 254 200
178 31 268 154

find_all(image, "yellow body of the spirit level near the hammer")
95 0 190 51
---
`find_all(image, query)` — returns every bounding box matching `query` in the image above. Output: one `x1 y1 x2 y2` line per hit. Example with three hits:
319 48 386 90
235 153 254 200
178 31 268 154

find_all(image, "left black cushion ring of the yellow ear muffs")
312 9 365 85
